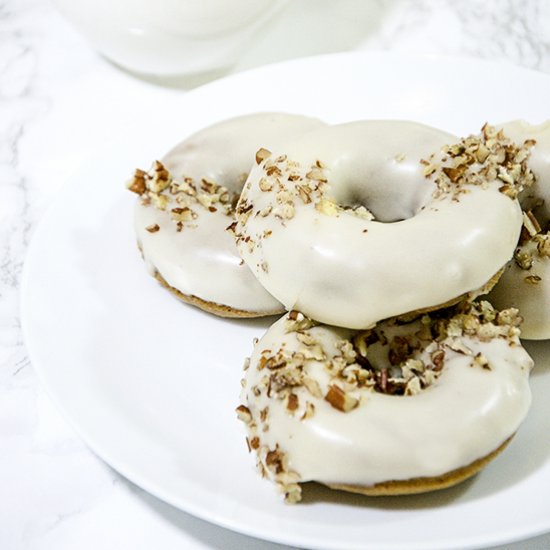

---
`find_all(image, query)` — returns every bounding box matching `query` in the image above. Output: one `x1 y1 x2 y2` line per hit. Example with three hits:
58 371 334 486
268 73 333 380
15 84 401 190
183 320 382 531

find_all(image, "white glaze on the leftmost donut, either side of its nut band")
135 113 322 314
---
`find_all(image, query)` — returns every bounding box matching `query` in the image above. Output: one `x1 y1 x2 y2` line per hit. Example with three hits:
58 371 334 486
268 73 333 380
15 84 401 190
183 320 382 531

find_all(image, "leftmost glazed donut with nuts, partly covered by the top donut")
129 113 328 317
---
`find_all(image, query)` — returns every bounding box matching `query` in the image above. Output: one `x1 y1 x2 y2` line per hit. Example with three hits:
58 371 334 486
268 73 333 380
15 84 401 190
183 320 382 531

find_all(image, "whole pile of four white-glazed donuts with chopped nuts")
128 113 550 502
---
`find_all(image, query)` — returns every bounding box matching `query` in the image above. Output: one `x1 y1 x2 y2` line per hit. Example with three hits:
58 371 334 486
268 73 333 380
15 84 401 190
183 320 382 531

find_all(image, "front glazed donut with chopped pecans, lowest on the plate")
237 301 533 502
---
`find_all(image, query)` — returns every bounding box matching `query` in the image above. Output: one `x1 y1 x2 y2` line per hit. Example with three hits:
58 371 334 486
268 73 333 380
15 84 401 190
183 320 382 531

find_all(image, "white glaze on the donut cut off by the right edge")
489 120 550 340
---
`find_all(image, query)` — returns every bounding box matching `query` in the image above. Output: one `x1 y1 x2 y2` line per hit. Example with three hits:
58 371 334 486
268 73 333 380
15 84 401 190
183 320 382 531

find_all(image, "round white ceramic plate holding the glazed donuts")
22 54 550 549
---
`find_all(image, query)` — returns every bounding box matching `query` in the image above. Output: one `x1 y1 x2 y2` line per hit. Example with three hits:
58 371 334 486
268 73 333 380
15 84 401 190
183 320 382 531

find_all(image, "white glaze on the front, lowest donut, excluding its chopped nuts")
242 316 533 486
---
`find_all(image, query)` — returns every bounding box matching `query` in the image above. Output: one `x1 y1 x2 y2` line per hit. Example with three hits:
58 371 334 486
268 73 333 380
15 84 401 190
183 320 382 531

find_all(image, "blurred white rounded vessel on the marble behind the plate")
54 0 288 76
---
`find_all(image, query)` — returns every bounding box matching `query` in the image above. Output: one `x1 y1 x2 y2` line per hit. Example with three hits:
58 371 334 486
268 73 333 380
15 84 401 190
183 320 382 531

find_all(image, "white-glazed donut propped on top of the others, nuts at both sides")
236 121 529 329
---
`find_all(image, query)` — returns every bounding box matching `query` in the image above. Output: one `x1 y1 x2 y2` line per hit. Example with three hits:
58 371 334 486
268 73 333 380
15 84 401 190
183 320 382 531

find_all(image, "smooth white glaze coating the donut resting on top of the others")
237 121 521 328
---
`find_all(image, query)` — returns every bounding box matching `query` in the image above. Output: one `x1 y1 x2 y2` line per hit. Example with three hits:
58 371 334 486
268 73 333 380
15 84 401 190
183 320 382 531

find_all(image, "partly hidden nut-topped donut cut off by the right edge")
488 120 550 340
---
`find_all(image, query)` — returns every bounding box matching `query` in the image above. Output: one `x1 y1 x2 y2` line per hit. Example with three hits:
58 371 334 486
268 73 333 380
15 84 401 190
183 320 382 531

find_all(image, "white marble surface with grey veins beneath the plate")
0 0 550 550
